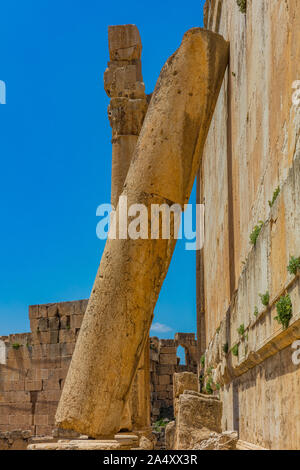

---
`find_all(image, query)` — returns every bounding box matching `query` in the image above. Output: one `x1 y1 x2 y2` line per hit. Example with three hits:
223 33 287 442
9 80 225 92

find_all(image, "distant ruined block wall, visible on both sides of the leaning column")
0 300 197 436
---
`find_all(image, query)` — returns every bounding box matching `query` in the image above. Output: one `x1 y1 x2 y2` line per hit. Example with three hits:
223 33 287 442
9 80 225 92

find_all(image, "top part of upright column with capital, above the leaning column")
104 25 148 208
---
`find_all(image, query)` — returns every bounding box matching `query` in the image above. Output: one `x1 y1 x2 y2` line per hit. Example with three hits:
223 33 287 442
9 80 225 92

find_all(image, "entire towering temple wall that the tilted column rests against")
197 0 300 449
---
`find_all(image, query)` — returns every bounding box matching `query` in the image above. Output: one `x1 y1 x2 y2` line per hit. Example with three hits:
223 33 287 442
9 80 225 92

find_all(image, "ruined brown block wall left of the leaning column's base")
0 300 87 436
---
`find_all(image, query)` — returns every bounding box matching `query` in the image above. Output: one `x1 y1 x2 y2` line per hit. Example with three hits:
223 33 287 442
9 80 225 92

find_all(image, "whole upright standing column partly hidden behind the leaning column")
104 25 150 430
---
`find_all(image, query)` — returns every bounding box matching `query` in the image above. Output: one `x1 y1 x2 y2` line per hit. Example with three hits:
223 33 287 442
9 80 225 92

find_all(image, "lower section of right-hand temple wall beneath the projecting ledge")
221 346 300 450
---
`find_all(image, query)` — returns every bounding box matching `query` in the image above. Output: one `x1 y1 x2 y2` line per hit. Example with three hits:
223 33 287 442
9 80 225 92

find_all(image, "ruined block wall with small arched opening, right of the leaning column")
150 333 197 422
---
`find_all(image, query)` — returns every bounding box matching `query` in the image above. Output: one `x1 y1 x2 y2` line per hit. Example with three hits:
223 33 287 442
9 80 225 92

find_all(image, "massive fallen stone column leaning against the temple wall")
56 28 228 437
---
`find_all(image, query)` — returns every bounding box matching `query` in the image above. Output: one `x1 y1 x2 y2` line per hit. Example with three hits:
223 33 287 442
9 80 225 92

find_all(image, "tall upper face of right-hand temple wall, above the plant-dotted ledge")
201 0 300 339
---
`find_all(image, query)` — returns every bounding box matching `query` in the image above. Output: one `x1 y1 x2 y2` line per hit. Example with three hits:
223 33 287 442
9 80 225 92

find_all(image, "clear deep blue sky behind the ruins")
0 0 204 337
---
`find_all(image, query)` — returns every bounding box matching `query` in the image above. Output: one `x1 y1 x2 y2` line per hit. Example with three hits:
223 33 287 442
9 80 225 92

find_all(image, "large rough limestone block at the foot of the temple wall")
174 392 222 450
